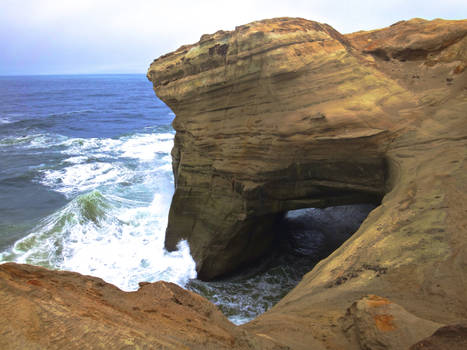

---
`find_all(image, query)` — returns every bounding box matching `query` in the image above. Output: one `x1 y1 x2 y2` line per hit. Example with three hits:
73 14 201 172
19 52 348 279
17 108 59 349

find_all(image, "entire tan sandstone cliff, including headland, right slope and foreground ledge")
0 18 467 350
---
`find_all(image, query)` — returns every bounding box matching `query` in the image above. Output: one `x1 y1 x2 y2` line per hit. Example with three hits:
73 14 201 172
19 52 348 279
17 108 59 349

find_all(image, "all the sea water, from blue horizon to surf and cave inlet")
0 75 372 323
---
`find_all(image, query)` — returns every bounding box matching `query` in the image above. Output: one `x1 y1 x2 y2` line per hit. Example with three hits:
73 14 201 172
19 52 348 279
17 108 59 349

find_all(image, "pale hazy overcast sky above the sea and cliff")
0 0 467 75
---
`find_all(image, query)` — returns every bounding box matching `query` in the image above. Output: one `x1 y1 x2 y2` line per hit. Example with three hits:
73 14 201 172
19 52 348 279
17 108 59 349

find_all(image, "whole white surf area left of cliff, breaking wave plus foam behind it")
0 133 196 290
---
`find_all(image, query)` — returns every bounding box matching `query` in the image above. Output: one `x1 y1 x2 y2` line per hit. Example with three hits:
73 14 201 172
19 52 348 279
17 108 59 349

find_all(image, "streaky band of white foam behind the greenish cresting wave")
34 133 173 198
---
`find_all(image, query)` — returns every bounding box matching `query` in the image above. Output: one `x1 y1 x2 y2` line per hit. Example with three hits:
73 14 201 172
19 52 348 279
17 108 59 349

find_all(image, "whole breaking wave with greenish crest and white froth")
0 191 196 291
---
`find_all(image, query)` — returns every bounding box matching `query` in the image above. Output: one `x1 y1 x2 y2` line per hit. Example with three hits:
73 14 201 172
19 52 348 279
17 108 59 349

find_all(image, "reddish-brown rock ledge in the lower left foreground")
0 263 280 350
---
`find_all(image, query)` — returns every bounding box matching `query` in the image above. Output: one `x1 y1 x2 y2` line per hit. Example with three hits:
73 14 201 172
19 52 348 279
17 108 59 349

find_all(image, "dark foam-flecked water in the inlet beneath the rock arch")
187 204 376 324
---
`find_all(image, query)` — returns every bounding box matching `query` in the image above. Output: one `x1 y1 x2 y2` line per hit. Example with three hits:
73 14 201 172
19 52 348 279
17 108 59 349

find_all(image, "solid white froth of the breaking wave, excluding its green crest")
61 194 196 290
